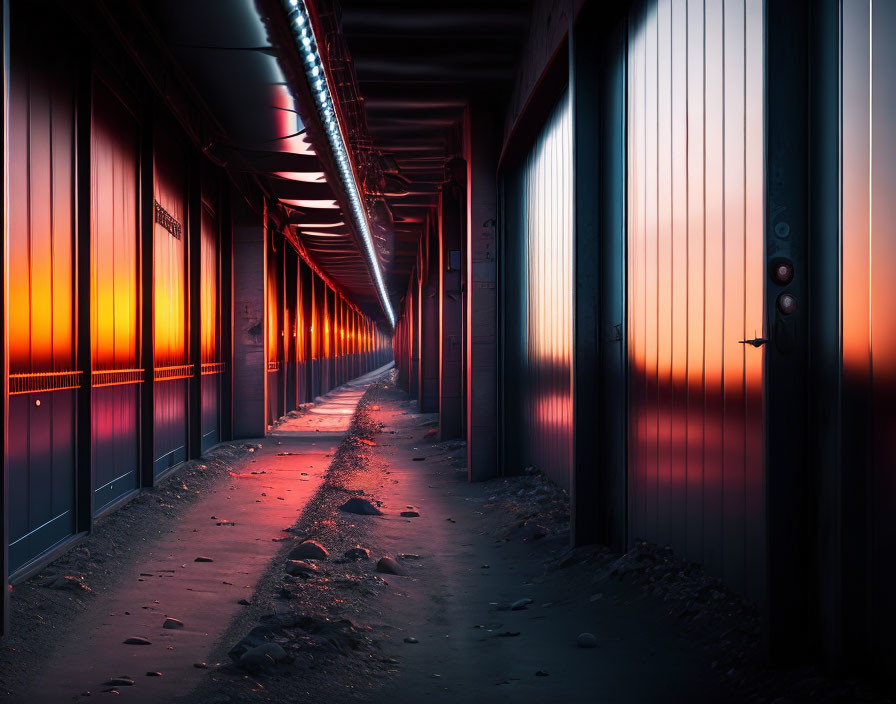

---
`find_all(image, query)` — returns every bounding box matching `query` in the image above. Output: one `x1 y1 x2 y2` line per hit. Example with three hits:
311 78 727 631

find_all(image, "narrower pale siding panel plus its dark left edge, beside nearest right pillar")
501 90 573 489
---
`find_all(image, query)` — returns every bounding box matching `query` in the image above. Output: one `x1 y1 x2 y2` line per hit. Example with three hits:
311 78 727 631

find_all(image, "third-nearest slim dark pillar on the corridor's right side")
419 216 439 413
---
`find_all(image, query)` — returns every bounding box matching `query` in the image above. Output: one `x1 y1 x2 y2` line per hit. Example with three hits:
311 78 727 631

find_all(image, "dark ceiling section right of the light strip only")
336 0 532 295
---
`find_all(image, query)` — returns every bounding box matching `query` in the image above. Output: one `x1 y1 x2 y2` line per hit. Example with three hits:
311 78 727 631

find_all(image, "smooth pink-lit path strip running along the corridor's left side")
0 372 384 704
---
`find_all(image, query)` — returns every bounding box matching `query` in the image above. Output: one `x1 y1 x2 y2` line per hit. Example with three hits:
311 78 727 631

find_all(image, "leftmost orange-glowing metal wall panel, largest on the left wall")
4 15 80 571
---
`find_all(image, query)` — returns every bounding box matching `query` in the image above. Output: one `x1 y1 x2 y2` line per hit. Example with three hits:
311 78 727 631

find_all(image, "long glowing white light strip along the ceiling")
283 0 395 328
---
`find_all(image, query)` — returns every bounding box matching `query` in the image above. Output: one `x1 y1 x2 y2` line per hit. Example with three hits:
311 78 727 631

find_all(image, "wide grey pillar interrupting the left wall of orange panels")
233 190 267 438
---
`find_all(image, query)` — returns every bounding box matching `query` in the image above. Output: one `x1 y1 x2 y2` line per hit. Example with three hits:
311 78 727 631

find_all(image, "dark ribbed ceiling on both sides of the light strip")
137 0 532 318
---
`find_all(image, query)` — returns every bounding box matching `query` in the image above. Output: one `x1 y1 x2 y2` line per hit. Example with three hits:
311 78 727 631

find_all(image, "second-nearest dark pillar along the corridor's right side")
439 164 467 440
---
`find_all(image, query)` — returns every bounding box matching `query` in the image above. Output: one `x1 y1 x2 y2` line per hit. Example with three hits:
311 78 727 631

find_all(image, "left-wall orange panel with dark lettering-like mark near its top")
153 129 189 475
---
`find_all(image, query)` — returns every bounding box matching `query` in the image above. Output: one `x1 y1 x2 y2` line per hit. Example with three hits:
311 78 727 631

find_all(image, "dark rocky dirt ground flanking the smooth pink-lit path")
0 375 889 704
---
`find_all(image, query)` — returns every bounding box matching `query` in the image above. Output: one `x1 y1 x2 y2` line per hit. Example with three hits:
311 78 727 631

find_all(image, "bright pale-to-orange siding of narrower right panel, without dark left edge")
520 92 572 488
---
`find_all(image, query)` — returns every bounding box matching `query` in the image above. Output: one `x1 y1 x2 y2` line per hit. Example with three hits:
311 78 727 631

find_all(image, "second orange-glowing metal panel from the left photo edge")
90 79 143 511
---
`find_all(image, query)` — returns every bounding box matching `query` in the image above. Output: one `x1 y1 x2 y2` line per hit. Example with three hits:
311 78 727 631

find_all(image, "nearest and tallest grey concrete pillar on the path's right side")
464 102 501 481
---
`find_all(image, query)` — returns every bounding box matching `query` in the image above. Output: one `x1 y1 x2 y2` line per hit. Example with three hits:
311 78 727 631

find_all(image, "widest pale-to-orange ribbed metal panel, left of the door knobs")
628 0 765 600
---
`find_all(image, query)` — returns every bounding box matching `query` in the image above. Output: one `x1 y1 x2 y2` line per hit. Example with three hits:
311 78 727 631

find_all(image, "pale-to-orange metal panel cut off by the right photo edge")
841 0 896 671
